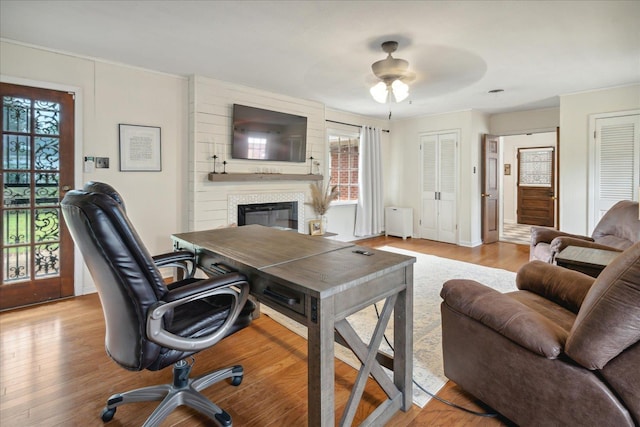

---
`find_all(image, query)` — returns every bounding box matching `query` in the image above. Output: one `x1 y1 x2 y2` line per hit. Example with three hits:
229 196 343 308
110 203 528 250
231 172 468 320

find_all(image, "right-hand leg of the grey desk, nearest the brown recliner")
393 264 413 411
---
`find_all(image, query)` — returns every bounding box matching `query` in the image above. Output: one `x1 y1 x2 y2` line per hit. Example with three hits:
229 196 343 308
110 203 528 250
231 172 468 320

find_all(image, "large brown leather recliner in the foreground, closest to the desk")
441 243 640 427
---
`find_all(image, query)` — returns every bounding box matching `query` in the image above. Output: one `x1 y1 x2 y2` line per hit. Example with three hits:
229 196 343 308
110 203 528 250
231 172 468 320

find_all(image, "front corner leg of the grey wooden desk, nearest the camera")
307 298 335 427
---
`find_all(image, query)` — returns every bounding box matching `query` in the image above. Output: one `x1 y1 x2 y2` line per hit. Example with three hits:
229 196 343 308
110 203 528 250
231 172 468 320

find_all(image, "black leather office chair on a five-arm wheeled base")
61 190 255 426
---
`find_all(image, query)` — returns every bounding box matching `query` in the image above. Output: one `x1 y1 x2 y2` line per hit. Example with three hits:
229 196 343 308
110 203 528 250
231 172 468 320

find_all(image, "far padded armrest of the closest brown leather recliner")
516 261 595 313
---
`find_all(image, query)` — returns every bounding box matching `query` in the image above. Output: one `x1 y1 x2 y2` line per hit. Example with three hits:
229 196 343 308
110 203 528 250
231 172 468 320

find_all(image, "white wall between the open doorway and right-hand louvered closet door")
559 85 640 234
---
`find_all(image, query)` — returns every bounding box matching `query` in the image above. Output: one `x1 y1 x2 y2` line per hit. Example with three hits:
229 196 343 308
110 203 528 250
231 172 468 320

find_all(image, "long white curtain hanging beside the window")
354 126 384 237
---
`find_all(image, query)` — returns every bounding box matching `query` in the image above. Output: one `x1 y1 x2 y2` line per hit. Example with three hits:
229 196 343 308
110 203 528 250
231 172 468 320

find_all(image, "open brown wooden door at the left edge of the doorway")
481 135 500 243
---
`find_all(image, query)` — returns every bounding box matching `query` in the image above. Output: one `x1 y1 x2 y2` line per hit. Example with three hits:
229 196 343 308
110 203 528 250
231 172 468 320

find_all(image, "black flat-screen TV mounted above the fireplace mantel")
231 104 307 162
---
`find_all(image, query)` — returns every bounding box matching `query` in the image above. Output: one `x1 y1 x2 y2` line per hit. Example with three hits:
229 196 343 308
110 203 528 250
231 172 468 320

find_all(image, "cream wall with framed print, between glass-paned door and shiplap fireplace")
0 41 188 294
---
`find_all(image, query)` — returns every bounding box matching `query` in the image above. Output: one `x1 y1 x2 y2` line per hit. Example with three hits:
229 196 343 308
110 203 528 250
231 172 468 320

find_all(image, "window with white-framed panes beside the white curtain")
329 134 360 201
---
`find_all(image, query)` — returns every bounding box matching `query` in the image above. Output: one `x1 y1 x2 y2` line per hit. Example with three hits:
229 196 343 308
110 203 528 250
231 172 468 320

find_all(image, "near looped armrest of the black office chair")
147 273 249 351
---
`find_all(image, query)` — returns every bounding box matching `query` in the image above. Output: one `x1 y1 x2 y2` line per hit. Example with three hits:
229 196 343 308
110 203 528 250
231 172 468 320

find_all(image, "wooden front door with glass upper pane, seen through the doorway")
518 147 556 227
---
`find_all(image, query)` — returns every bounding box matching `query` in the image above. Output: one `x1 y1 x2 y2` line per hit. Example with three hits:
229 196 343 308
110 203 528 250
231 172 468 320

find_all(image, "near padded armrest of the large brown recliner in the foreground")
440 279 568 359
